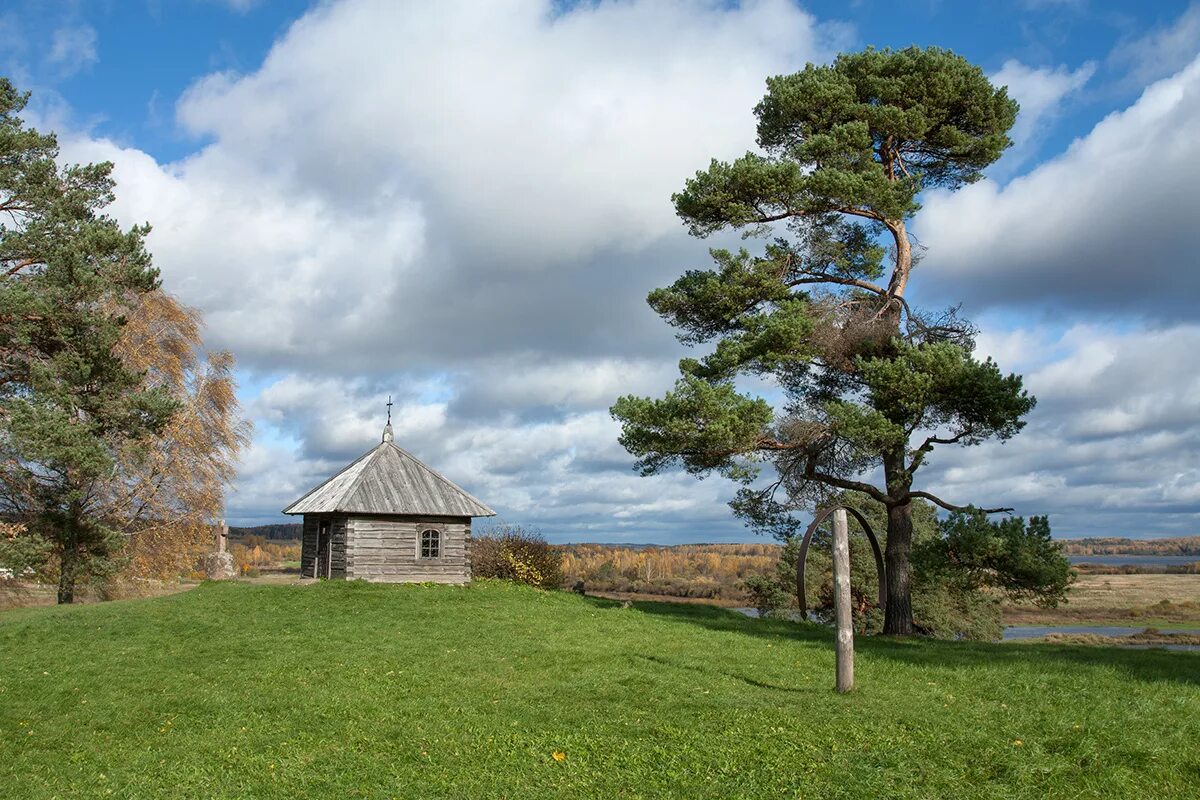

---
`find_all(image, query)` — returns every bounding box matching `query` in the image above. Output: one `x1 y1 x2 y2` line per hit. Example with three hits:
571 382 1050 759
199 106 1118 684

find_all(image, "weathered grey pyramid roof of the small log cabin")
283 438 496 517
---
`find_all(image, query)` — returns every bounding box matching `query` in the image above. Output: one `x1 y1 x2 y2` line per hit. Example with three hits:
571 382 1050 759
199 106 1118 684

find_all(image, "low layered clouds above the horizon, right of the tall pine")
923 324 1200 536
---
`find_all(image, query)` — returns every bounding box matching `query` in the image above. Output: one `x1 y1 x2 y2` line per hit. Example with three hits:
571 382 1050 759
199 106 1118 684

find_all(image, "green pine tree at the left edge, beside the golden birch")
0 78 176 603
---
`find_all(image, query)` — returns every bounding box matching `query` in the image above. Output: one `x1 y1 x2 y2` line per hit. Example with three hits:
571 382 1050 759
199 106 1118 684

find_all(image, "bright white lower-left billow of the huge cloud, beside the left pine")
64 131 425 368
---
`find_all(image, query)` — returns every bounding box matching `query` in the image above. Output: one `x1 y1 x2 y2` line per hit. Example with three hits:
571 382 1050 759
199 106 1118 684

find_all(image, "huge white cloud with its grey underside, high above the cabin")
56 0 823 373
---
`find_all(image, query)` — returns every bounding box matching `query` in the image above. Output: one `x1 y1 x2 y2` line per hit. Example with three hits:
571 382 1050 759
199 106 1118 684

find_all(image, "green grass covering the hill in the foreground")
0 583 1200 799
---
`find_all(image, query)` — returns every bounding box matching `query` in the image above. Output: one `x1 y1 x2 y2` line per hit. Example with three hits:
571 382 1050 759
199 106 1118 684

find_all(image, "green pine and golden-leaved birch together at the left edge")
0 78 250 603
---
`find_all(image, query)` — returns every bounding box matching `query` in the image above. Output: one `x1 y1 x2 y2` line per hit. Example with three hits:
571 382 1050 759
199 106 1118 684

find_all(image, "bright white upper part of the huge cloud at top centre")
171 0 816 267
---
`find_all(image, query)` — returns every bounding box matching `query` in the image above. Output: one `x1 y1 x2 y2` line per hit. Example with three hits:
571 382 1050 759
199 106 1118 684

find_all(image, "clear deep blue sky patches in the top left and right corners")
16 0 1188 161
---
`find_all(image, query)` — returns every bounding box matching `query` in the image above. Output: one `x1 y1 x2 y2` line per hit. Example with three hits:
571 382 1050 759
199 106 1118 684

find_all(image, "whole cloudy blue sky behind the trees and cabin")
0 0 1200 542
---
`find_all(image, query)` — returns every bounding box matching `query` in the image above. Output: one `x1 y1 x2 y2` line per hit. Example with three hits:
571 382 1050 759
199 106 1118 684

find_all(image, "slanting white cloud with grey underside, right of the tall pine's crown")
917 52 1200 319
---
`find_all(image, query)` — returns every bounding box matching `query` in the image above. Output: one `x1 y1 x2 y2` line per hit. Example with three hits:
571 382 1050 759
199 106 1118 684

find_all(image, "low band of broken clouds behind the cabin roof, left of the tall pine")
229 365 744 541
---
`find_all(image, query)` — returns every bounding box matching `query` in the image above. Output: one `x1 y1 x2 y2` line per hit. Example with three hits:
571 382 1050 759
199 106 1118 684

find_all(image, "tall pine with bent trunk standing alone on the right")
612 48 1034 633
